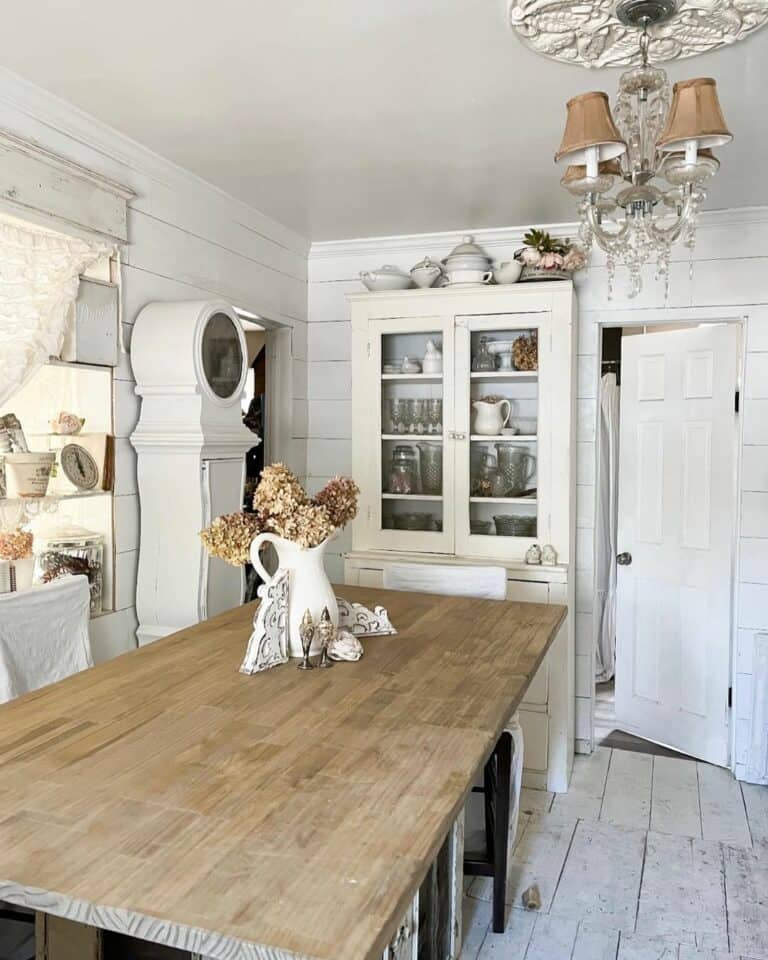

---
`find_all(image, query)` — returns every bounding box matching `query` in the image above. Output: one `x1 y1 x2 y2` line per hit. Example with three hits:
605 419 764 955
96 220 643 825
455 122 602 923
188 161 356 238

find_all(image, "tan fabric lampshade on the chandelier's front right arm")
657 77 733 152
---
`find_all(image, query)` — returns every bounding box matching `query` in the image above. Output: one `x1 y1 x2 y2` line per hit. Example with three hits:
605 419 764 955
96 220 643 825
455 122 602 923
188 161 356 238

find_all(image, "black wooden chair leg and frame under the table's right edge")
464 730 512 933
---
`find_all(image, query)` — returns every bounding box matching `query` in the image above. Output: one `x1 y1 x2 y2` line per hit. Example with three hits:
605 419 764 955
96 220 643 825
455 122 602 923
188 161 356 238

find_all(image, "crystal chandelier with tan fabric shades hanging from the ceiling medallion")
555 0 732 297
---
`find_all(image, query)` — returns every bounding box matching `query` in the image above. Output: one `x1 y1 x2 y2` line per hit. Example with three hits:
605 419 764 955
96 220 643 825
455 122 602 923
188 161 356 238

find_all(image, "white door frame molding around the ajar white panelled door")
588 307 749 770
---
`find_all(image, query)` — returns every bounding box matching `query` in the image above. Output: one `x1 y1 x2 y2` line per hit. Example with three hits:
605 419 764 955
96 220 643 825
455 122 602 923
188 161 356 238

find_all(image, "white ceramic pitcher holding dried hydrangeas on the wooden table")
251 533 339 657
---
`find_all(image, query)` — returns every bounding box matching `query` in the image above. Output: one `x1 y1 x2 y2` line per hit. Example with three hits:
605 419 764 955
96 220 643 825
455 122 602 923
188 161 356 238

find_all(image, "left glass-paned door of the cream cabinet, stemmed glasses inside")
368 317 454 552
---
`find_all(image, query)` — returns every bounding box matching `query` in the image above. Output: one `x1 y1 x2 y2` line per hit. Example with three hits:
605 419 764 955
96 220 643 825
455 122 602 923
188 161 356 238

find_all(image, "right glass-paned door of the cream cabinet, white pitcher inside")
455 313 548 560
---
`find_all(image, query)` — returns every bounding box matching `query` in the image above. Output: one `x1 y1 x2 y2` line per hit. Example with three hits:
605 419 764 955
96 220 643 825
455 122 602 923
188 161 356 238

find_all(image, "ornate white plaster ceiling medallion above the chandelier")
509 0 768 67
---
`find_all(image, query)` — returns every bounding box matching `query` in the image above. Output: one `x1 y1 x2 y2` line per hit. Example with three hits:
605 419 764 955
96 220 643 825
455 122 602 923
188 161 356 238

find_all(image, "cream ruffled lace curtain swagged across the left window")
0 218 111 410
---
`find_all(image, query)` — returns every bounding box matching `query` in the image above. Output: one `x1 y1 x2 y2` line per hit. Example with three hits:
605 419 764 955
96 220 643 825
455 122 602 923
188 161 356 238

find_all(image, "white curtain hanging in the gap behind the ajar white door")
595 373 619 683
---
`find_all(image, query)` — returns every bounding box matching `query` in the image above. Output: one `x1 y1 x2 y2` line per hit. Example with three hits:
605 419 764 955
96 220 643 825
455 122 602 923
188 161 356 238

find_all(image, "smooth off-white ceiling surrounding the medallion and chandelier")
0 0 768 240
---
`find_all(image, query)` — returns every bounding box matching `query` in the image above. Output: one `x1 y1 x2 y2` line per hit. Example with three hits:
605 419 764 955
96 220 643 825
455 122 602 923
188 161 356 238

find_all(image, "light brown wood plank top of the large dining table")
0 586 565 960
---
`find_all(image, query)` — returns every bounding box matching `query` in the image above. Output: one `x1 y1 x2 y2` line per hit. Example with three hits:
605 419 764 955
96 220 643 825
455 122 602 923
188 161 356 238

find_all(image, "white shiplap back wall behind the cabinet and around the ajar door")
307 208 768 779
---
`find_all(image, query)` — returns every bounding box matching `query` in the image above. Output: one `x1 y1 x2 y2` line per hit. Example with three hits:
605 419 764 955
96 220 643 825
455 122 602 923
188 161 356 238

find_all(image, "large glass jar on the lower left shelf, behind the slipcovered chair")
33 525 104 617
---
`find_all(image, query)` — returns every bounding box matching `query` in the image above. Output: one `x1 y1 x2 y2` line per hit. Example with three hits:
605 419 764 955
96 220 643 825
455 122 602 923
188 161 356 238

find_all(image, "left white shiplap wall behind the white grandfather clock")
0 71 309 659
